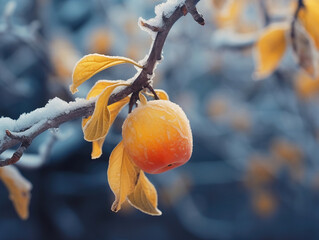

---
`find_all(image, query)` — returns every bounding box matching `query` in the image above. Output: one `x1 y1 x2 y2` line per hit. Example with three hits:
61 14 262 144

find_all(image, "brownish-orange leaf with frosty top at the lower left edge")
0 166 32 220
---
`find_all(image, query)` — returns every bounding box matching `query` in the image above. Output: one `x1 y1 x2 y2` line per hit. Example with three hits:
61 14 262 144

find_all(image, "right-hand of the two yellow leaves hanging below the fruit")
128 170 162 216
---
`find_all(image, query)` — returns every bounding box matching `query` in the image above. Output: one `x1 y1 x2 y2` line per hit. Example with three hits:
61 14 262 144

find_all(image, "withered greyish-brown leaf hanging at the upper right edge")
292 21 319 78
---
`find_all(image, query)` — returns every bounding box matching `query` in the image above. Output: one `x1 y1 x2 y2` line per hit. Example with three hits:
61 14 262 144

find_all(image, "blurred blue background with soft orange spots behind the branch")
0 0 319 240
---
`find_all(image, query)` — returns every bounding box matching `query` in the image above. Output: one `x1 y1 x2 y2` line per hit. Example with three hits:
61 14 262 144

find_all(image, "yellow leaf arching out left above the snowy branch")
70 54 143 94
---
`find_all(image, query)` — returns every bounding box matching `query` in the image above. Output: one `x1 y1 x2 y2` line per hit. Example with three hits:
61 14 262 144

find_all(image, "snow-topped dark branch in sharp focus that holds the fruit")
0 0 204 167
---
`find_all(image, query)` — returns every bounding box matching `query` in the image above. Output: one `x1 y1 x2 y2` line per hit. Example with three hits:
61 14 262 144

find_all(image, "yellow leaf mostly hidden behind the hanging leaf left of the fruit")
87 97 130 159
